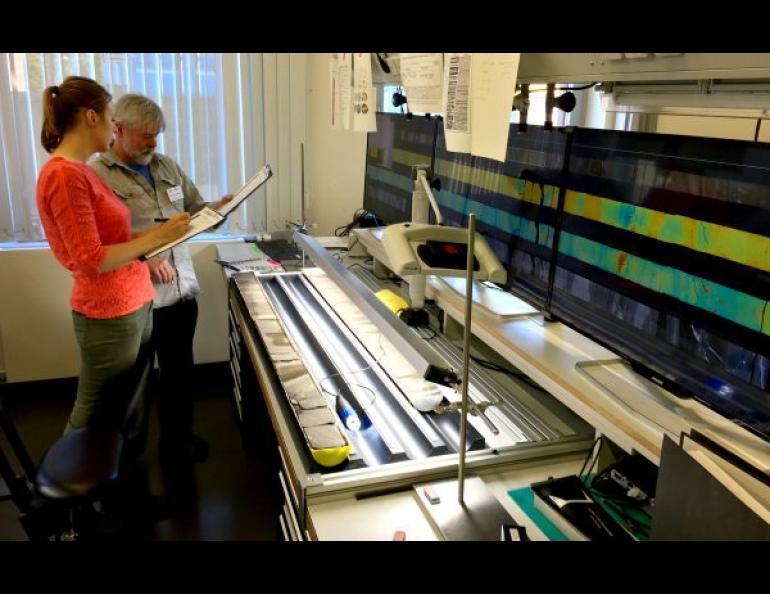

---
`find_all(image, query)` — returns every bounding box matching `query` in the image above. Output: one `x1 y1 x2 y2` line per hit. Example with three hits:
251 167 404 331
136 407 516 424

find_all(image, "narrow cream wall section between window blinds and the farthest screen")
305 54 366 235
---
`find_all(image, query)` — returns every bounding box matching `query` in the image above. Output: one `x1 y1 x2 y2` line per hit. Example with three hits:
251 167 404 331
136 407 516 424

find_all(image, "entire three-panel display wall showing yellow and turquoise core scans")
364 114 770 440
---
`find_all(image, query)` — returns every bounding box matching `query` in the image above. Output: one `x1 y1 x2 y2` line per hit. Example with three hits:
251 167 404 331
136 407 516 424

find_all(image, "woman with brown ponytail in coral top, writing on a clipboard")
37 76 190 454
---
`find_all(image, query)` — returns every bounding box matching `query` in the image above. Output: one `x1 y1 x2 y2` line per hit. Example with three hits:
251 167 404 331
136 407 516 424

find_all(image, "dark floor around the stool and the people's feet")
0 365 281 540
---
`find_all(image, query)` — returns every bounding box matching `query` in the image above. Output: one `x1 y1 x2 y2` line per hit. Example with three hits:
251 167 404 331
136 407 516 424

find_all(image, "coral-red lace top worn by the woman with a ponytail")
37 157 155 319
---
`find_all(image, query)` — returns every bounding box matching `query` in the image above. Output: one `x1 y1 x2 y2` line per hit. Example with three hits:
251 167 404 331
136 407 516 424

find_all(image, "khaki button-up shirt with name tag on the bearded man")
88 150 206 308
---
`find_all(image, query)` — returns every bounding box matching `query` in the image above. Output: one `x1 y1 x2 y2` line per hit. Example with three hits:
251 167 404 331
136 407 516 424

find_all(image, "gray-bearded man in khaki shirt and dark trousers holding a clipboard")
89 94 232 463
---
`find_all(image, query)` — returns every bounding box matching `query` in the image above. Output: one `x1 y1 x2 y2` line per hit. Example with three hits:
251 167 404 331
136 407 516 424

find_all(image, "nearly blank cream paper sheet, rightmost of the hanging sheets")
470 53 519 161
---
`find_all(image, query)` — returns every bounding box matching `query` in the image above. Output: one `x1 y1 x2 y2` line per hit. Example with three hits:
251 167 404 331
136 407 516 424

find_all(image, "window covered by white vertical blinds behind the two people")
0 53 291 242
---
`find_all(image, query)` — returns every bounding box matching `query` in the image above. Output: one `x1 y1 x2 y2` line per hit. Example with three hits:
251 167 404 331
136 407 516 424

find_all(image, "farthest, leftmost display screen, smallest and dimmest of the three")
364 113 436 225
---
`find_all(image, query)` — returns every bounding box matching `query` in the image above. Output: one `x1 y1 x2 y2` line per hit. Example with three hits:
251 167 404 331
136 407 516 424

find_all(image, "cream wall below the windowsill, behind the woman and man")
0 242 229 382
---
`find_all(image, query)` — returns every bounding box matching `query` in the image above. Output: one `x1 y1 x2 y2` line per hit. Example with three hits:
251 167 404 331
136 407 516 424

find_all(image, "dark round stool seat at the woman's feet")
35 427 123 499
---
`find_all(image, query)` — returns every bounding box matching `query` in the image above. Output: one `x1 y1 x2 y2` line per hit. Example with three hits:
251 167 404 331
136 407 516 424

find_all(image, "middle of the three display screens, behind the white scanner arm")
434 122 565 308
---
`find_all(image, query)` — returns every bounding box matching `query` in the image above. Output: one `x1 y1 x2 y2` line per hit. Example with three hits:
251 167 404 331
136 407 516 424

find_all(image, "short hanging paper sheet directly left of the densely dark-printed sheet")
401 54 444 113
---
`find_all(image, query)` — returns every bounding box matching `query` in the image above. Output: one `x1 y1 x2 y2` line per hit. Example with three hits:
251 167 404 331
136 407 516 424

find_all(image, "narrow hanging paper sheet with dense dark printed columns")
442 53 471 153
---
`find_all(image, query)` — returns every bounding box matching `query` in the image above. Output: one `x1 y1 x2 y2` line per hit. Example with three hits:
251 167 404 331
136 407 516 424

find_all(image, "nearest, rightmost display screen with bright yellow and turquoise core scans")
552 129 770 439
